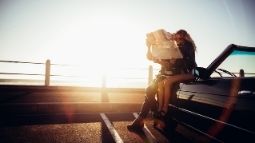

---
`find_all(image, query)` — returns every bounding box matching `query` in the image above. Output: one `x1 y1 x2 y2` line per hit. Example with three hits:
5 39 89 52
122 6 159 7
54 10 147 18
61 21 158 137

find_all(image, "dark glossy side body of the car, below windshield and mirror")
170 77 255 142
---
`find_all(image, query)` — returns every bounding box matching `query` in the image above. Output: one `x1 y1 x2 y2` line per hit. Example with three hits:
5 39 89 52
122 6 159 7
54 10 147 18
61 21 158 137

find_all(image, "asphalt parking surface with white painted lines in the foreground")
0 113 188 143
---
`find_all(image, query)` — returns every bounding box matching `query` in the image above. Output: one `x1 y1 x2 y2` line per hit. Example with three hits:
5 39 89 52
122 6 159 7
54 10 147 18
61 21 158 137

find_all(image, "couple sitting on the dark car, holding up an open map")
127 29 197 131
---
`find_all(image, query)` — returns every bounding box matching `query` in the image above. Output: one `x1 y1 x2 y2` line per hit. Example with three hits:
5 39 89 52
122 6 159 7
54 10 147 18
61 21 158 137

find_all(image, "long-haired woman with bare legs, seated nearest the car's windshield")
155 29 197 130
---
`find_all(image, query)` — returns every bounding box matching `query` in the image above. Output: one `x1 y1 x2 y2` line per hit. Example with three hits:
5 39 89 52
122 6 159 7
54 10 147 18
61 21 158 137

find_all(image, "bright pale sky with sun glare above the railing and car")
0 0 255 86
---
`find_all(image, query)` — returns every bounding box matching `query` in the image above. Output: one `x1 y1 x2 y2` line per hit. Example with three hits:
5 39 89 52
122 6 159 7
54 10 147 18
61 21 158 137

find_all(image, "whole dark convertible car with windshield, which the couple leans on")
169 44 255 143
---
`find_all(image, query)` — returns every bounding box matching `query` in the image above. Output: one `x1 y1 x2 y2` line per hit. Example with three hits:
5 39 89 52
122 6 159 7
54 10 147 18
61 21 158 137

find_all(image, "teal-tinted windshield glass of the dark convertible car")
211 50 255 77
